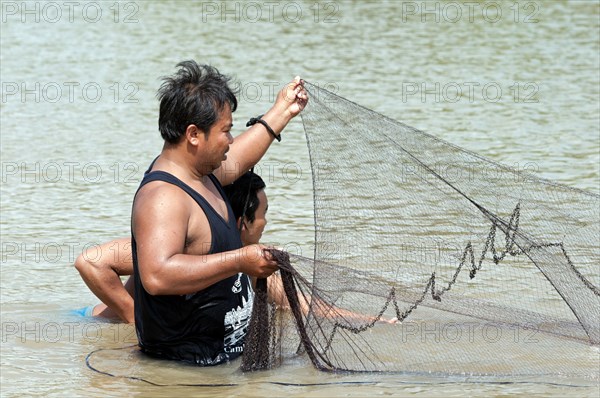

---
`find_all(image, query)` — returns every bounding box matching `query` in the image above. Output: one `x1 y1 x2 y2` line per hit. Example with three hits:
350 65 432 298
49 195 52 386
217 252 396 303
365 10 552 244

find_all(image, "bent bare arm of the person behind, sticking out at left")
75 238 135 323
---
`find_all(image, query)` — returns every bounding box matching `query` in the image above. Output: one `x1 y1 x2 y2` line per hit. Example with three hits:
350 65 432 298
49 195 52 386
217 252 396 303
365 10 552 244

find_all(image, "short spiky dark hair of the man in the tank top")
157 60 237 144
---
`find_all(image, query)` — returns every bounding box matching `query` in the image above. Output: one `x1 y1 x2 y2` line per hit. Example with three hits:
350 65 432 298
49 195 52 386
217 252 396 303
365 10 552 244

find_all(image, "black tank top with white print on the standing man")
131 171 253 366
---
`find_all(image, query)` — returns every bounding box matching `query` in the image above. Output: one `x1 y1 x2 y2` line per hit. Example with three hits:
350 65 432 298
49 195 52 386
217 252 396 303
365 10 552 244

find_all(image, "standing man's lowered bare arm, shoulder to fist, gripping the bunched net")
133 182 277 295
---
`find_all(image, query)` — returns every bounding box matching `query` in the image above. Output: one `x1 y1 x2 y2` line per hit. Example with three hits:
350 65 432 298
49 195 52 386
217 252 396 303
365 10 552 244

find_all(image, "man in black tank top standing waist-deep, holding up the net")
79 61 308 365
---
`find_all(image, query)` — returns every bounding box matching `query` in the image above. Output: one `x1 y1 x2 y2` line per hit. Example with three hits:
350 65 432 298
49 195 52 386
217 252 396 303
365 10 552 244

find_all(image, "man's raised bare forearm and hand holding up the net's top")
214 77 308 185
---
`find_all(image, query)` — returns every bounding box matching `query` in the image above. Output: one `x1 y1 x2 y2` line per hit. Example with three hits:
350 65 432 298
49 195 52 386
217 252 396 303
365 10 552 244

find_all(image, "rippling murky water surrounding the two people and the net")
0 1 600 396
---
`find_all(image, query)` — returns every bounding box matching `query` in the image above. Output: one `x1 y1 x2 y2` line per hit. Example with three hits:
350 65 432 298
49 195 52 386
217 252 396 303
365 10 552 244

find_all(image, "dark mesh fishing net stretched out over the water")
242 83 600 382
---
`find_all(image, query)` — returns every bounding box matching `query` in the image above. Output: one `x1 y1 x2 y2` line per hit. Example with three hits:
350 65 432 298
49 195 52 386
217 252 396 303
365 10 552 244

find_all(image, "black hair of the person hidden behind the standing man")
223 171 265 222
